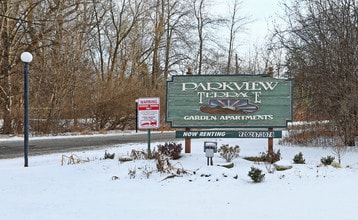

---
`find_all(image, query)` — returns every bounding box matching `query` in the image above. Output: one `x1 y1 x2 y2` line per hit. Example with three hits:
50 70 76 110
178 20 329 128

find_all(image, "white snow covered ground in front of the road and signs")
0 135 358 220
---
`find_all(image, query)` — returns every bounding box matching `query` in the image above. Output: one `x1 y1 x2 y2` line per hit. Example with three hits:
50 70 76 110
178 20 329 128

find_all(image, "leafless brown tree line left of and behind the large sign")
0 0 256 134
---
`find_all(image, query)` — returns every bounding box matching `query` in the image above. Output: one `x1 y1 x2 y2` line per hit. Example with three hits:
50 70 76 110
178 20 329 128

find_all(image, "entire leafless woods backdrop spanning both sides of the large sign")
0 0 358 144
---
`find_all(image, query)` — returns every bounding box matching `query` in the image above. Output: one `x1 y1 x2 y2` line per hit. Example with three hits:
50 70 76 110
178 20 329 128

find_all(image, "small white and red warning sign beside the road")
137 97 160 129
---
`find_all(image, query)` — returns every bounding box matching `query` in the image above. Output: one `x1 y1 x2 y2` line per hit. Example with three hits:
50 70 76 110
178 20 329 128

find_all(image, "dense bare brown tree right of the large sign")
276 0 358 146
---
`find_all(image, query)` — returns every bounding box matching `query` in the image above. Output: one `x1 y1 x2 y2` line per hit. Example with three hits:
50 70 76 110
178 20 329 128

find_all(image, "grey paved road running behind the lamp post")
0 132 176 159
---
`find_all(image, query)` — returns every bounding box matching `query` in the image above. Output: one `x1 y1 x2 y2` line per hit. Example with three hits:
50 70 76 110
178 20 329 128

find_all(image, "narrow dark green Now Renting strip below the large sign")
175 130 282 138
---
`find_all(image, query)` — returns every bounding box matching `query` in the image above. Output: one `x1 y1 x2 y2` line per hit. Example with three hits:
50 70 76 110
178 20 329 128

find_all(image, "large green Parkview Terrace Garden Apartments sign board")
166 75 293 128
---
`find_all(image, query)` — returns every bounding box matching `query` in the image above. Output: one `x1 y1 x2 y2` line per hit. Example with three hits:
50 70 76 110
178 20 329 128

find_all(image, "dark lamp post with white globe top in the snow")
20 52 32 167
